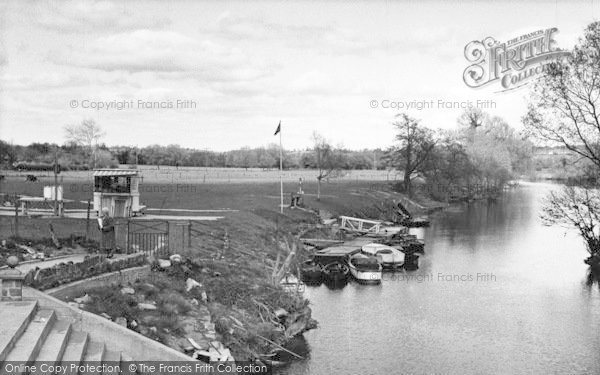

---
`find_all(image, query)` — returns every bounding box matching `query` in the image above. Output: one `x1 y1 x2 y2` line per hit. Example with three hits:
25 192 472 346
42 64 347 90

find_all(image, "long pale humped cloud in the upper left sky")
51 29 265 82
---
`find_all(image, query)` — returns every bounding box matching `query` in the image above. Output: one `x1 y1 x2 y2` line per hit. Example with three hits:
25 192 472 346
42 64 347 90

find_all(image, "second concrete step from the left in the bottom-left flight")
6 310 56 362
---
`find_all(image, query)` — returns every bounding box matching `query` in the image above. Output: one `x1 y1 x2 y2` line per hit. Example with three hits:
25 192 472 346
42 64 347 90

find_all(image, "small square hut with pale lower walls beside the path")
94 169 145 217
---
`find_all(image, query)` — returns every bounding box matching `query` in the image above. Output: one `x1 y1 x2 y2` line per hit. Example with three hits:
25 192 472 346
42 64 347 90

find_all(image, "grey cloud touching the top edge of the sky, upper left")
32 0 171 33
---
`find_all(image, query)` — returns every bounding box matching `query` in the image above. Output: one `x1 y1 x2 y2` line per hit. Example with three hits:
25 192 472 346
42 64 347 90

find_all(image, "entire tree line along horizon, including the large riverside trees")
0 107 533 206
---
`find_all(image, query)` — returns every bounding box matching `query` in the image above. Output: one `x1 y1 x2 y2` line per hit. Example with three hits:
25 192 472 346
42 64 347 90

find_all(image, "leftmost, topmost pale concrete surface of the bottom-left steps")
0 301 37 363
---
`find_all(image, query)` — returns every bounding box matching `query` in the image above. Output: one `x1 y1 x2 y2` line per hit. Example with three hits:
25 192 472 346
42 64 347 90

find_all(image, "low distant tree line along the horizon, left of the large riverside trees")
0 140 389 170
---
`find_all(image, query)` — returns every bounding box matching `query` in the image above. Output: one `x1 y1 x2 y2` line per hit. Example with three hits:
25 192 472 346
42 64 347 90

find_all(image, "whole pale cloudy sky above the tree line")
0 0 600 151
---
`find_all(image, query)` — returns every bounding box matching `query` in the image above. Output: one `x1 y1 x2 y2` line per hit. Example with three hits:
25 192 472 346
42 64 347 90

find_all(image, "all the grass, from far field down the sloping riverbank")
0 167 436 360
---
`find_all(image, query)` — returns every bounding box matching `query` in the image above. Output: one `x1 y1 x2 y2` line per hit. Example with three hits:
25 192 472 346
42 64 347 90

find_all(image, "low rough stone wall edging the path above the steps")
25 254 146 290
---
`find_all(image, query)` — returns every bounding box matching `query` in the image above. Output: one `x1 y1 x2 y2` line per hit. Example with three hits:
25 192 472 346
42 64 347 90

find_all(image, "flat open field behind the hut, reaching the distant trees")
0 166 400 209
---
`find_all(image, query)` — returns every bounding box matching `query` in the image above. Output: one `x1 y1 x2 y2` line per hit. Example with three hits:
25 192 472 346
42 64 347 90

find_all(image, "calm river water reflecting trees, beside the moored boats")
278 183 600 375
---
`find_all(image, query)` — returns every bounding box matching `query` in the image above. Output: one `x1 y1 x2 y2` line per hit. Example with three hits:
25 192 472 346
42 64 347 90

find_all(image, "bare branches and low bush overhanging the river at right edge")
523 22 600 266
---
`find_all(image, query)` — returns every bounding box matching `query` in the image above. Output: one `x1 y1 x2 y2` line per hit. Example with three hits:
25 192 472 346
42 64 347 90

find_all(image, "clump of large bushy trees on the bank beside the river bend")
386 107 534 200
